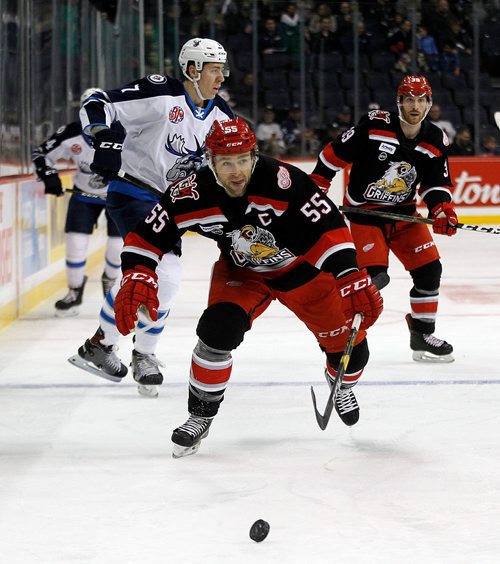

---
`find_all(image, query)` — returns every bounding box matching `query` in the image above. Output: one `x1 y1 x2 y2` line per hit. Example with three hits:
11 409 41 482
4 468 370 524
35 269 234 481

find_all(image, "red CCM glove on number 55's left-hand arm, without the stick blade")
115 266 160 335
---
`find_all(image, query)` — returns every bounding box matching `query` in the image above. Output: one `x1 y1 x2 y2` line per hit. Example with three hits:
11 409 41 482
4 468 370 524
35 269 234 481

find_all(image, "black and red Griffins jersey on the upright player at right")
313 110 453 223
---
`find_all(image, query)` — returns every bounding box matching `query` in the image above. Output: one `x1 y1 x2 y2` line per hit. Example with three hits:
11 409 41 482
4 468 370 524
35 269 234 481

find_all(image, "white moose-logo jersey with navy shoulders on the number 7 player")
80 74 234 194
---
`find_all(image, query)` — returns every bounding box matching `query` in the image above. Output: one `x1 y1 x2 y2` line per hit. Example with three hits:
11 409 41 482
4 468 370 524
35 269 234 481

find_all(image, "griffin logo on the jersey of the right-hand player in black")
364 162 417 205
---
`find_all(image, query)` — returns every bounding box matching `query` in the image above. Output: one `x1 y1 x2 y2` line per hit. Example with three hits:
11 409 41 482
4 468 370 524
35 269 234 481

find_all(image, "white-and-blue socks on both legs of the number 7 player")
99 252 181 354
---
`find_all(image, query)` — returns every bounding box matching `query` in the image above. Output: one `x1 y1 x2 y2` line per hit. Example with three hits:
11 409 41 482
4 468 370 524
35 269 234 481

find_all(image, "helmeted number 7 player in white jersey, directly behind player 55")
69 38 233 397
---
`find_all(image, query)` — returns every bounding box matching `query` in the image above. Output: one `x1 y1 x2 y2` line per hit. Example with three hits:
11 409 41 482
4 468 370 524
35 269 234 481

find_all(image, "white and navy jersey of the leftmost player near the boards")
32 121 106 197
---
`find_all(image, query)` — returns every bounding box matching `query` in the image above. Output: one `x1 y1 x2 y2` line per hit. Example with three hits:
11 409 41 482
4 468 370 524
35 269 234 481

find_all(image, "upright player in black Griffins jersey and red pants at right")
311 76 457 362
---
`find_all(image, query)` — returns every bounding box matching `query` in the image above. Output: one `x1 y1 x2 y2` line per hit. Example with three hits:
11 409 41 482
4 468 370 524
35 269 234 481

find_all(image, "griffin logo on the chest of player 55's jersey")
226 225 295 270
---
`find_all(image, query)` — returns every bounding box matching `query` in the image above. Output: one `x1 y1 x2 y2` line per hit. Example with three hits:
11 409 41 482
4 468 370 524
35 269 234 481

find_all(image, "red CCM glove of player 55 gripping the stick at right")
337 268 384 329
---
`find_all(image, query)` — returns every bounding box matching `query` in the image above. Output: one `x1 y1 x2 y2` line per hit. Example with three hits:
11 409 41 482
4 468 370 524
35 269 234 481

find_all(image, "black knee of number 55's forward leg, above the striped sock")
196 302 250 351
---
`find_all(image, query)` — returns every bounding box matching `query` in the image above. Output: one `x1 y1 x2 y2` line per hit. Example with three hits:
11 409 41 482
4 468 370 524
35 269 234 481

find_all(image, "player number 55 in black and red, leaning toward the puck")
110 118 382 458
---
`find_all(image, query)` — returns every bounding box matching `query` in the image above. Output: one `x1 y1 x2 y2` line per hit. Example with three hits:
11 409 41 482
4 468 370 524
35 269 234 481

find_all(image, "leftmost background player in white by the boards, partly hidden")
32 88 123 317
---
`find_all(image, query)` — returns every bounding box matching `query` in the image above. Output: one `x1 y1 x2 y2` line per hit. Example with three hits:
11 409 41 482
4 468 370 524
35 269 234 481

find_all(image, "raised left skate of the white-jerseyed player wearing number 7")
68 328 127 382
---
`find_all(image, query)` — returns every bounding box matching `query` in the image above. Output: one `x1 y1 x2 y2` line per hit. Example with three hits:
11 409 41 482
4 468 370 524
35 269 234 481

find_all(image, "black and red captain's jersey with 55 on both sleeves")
122 156 357 289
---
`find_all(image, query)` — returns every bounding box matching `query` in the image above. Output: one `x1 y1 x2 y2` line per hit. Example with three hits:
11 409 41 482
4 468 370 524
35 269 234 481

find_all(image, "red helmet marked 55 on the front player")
205 118 257 156
